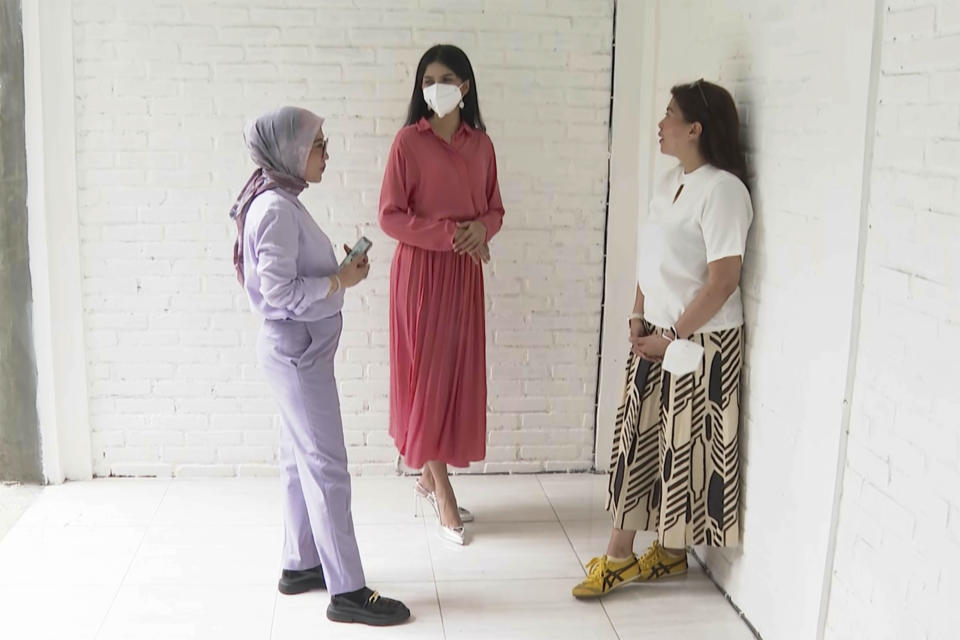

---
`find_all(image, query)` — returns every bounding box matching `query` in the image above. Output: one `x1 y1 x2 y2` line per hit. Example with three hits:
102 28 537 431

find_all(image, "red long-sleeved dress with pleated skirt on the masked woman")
380 119 503 468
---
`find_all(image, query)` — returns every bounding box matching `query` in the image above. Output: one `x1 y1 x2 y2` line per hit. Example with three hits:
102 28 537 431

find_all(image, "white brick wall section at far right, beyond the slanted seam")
827 0 960 640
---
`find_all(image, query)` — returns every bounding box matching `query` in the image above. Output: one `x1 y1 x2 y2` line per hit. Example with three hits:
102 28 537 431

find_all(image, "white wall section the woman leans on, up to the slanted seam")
618 0 873 640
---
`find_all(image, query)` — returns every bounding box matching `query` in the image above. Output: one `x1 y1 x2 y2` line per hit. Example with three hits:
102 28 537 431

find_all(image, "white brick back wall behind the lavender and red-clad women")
74 0 613 475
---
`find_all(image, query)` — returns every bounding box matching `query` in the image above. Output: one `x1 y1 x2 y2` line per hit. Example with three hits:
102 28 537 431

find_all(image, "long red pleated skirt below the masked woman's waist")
390 243 487 469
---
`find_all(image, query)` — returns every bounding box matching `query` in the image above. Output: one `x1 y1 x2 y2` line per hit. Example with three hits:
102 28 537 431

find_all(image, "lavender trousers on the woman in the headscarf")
257 314 366 595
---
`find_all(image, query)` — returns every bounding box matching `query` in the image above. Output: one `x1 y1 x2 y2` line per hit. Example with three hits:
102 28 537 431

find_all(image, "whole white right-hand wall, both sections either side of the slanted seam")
614 0 960 640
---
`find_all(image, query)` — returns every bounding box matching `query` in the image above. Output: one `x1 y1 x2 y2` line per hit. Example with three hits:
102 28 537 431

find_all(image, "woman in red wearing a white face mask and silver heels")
380 45 503 544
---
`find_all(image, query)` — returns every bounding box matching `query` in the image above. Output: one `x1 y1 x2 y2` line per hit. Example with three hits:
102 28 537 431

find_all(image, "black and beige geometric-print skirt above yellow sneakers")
607 326 743 549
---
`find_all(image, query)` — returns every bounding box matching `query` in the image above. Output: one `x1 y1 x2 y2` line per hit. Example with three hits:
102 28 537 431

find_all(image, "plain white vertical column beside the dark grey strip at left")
22 0 92 483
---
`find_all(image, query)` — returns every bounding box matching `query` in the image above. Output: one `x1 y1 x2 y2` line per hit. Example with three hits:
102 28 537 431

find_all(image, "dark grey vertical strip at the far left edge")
0 0 43 483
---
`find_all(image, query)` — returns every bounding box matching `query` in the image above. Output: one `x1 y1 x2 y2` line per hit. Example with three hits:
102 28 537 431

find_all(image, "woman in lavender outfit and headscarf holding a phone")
230 107 410 626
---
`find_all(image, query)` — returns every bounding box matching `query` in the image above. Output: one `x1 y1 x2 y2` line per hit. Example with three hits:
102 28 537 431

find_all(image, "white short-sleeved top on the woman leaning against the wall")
637 164 753 332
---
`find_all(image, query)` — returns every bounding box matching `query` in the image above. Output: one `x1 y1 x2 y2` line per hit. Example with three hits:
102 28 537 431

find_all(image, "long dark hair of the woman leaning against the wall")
670 78 749 187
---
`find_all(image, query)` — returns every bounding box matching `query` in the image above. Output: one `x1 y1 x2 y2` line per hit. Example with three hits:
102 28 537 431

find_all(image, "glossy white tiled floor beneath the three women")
0 475 752 640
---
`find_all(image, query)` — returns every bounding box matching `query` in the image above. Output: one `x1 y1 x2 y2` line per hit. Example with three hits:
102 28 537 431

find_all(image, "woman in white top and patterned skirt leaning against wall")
573 80 753 598
